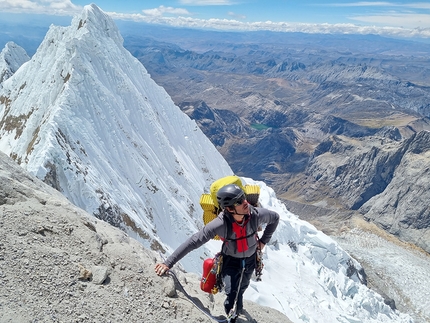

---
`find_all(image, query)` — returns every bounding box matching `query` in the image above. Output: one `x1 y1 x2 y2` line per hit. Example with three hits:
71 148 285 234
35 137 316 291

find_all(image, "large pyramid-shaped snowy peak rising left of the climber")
0 5 231 256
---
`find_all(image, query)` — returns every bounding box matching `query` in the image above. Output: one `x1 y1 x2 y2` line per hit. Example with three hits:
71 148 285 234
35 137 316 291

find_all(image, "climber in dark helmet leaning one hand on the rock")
155 184 279 323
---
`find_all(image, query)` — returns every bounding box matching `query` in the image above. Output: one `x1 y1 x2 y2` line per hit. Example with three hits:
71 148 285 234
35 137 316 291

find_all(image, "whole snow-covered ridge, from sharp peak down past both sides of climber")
0 5 412 323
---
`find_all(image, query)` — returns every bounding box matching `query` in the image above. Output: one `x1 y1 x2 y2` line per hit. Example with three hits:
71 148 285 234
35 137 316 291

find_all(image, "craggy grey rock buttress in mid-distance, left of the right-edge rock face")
299 132 401 210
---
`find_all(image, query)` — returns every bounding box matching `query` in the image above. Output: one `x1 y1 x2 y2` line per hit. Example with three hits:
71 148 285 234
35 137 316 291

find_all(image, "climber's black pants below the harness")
221 254 256 315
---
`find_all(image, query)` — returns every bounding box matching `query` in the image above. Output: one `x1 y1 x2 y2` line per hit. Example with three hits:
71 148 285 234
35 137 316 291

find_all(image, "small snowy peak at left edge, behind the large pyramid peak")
0 42 30 89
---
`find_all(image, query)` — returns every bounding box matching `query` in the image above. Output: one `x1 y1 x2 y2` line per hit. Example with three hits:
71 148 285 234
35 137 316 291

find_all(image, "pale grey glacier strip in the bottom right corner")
335 228 430 322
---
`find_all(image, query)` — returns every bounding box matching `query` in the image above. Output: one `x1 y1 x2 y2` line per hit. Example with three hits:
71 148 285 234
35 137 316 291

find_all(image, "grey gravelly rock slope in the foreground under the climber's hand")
0 153 290 323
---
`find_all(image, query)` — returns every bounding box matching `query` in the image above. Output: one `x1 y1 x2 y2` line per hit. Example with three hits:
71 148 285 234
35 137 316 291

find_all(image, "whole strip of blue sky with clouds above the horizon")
0 0 430 38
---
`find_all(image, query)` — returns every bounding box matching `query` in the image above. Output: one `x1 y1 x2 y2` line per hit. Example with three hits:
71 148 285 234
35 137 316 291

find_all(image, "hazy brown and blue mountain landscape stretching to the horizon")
123 22 430 252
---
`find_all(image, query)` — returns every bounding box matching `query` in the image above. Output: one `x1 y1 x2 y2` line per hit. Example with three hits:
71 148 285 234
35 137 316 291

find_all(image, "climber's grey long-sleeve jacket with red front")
164 205 279 268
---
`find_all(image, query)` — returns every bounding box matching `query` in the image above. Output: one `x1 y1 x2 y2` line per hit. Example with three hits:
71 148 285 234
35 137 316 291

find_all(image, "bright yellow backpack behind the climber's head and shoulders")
200 175 260 240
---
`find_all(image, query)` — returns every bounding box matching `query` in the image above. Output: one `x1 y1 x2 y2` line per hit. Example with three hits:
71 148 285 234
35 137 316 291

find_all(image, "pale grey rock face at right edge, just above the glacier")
360 131 430 252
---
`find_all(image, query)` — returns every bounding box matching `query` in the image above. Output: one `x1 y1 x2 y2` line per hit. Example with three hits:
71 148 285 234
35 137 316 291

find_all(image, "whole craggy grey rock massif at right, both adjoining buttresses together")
287 131 430 252
